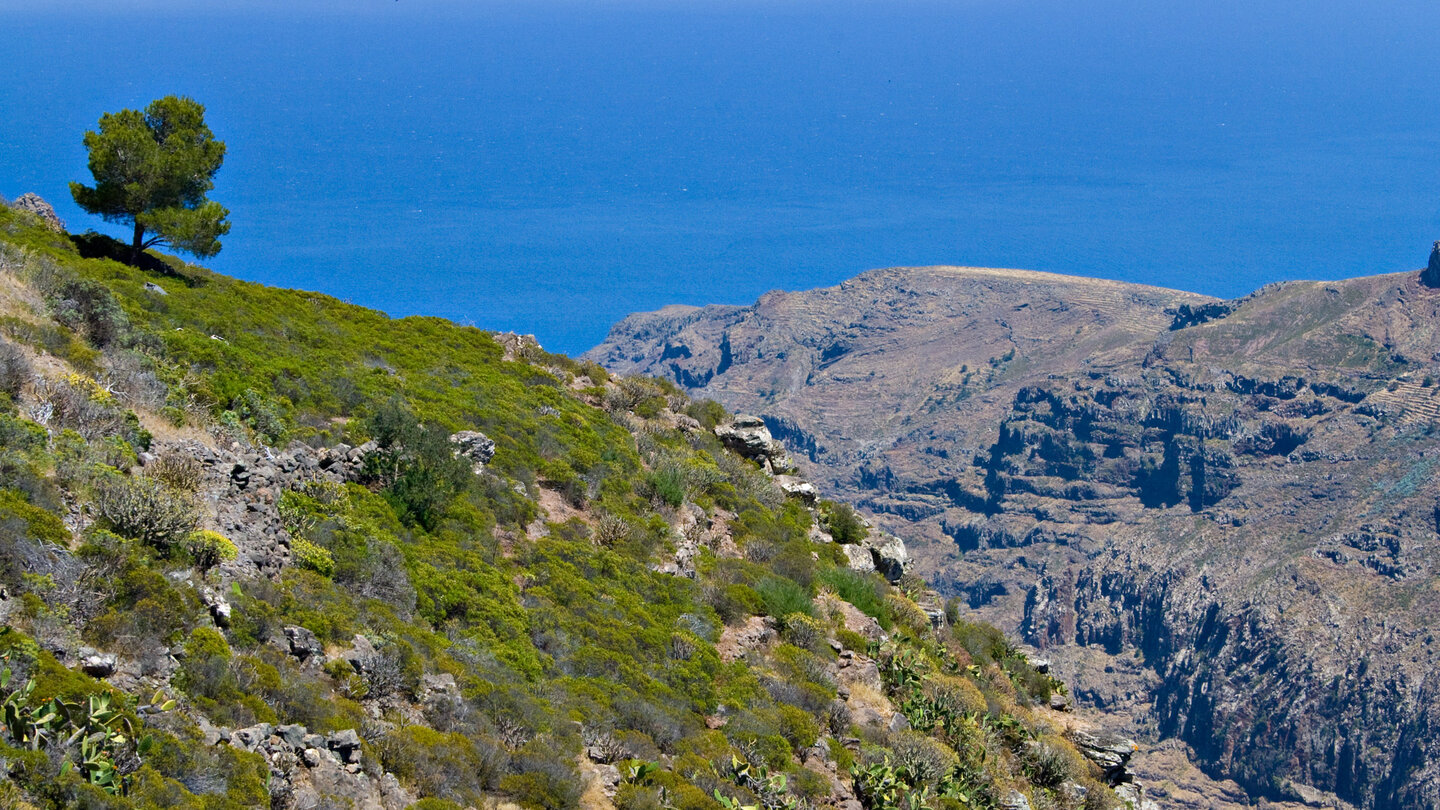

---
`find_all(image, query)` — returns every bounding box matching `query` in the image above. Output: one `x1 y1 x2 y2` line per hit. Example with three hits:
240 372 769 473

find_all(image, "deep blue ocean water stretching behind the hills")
0 0 1440 352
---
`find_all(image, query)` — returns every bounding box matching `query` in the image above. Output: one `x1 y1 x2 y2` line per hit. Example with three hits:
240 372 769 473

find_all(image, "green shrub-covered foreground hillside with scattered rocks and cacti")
0 206 1116 810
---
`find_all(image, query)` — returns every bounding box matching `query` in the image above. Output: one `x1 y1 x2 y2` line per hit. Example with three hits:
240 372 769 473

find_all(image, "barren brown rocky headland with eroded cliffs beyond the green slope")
590 268 1440 807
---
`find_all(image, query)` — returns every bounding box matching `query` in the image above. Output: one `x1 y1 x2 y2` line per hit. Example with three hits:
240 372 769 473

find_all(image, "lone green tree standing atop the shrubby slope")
71 95 230 258
